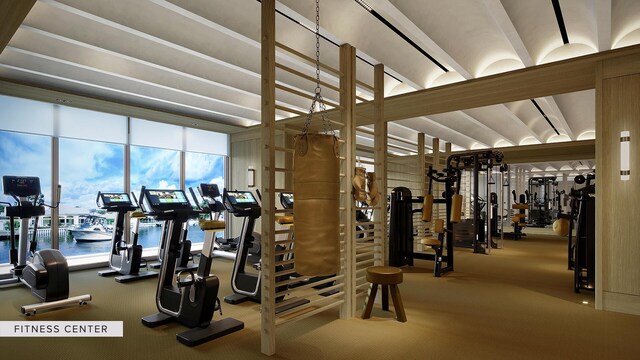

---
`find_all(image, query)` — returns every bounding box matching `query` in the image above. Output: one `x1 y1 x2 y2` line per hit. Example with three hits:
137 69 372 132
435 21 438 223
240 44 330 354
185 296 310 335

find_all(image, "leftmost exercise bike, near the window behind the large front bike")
96 192 158 283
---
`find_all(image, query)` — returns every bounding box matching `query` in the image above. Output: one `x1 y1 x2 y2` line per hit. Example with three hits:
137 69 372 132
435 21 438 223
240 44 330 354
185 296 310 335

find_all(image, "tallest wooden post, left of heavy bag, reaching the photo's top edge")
260 0 276 355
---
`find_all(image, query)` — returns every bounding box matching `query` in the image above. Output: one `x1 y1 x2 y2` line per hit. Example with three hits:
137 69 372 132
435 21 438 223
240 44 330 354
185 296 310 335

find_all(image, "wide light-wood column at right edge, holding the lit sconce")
596 55 640 315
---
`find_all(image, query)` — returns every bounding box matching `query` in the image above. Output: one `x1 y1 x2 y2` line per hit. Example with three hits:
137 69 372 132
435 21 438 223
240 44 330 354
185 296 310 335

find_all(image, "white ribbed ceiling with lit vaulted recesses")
0 0 640 156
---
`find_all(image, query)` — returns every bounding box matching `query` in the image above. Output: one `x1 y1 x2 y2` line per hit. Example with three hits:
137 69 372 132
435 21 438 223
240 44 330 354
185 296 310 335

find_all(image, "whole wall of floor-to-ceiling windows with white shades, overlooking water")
0 95 228 264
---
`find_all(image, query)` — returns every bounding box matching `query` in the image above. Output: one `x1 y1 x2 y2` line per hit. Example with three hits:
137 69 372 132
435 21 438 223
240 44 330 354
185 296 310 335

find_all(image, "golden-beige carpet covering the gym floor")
0 234 640 360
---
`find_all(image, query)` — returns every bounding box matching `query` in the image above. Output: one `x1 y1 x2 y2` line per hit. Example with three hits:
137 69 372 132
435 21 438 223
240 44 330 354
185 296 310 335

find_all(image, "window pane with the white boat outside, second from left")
57 106 127 259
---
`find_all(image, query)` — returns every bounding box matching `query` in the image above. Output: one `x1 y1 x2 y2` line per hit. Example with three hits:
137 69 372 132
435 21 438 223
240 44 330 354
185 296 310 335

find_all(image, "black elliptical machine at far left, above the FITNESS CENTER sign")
0 175 91 316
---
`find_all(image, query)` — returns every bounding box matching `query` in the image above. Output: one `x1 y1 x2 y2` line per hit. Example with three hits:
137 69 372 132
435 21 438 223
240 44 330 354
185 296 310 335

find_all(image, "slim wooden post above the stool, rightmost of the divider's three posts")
373 64 389 265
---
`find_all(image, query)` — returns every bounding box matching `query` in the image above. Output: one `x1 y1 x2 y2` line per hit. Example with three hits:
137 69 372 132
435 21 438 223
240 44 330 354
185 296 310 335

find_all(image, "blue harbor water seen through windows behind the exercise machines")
0 225 204 264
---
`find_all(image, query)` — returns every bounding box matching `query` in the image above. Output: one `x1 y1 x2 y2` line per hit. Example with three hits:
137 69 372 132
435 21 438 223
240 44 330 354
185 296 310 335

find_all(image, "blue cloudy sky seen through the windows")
0 131 224 214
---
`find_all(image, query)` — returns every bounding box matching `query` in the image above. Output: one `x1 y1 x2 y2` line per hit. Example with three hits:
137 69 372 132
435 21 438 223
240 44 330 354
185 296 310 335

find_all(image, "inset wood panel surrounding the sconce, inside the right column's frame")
596 74 640 298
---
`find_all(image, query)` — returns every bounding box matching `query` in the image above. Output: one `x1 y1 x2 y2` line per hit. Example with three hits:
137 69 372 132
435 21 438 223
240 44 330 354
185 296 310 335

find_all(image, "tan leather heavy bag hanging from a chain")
293 134 340 276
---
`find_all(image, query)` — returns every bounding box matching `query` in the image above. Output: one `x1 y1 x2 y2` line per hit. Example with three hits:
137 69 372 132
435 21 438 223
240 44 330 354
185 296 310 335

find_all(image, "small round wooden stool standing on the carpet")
362 266 407 322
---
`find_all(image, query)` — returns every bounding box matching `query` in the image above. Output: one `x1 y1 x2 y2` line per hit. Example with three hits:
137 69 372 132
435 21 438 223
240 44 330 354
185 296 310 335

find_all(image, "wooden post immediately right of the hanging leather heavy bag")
340 44 356 319
